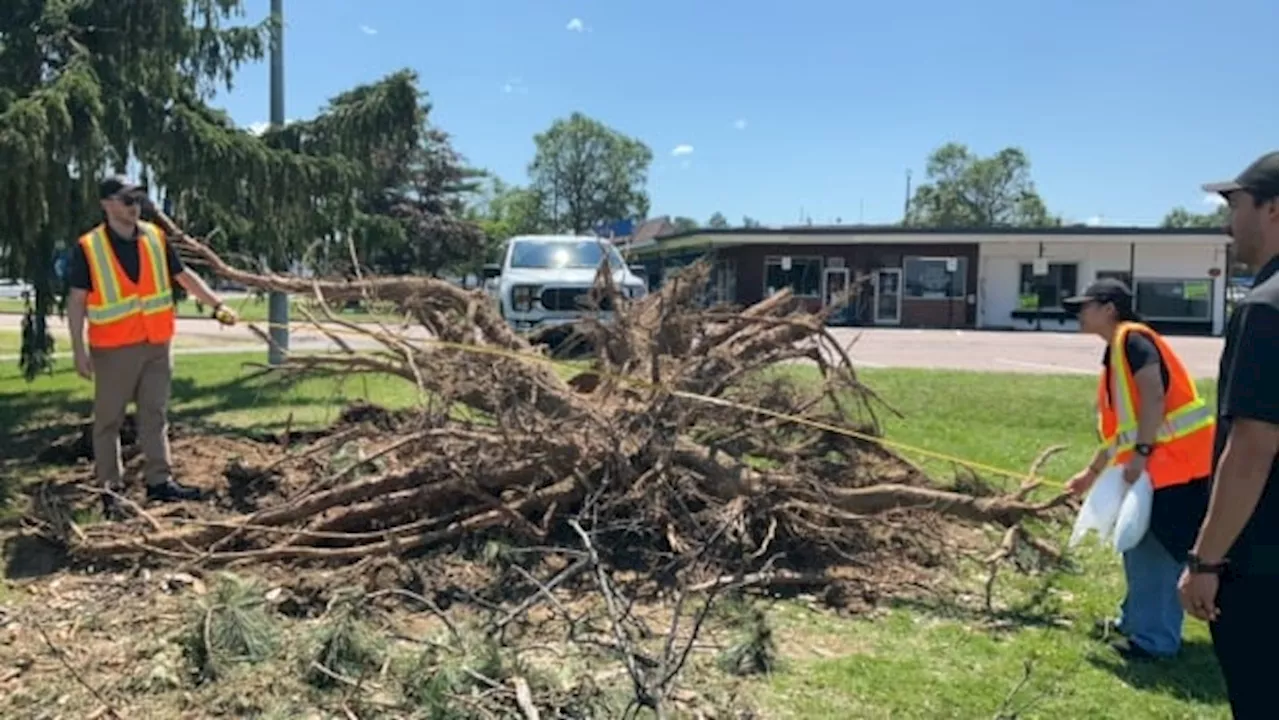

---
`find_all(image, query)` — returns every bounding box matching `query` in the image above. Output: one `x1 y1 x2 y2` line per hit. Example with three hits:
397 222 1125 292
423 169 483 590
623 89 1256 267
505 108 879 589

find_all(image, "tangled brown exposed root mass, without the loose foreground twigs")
27 225 1066 604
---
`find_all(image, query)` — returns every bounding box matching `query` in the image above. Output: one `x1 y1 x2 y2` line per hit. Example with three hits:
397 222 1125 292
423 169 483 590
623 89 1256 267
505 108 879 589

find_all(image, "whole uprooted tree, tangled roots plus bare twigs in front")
20 222 1065 716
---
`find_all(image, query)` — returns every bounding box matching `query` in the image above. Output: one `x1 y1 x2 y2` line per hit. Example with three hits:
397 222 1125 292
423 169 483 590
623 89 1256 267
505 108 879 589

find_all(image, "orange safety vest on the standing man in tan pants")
79 222 177 348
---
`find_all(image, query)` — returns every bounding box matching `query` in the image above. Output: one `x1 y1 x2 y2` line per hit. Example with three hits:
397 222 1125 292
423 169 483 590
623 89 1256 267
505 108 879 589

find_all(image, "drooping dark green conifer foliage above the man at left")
0 0 453 377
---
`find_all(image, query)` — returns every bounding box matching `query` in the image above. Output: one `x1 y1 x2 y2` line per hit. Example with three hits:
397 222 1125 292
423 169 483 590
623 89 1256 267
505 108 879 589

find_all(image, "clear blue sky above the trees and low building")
219 0 1280 224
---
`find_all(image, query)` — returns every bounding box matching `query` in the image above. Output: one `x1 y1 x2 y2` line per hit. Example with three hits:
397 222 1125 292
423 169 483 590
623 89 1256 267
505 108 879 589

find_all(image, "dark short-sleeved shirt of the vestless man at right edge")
1213 256 1280 574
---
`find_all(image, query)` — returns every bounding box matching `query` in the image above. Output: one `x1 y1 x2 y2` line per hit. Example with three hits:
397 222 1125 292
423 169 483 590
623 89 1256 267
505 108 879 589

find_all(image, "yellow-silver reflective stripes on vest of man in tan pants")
86 223 173 325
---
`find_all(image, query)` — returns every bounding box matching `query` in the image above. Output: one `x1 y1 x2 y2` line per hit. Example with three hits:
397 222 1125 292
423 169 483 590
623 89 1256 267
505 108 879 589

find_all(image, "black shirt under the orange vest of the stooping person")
1102 324 1210 560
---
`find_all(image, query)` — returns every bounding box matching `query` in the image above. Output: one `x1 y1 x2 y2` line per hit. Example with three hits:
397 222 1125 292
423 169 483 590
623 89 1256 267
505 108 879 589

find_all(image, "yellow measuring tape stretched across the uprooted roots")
217 312 1059 480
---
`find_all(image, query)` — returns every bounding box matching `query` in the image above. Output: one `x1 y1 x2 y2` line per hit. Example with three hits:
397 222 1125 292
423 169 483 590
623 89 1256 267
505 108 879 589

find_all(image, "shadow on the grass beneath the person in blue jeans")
1089 641 1226 703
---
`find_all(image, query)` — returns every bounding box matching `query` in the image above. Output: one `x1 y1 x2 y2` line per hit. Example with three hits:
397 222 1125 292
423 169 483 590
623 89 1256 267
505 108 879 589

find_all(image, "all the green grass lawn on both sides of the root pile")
0 354 1229 720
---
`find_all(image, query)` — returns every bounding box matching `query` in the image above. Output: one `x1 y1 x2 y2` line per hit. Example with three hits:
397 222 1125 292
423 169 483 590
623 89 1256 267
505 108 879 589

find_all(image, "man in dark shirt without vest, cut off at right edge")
1179 152 1280 719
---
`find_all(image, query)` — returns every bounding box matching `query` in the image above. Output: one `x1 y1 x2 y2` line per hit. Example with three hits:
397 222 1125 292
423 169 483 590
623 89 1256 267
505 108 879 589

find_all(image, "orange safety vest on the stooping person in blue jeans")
1098 323 1215 489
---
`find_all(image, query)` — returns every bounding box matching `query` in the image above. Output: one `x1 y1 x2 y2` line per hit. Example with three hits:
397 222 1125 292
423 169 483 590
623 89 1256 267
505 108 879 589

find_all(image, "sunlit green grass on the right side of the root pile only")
760 369 1229 719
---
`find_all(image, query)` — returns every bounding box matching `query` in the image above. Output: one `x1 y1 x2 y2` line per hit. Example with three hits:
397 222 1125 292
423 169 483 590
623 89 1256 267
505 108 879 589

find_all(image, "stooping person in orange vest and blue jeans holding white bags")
1062 278 1215 660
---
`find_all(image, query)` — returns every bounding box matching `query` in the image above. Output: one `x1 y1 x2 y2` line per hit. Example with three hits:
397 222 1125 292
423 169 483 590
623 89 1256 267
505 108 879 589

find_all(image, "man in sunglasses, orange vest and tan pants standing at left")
67 177 236 512
